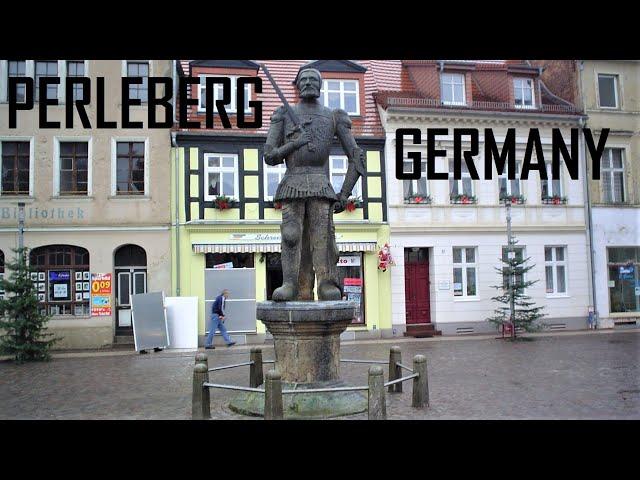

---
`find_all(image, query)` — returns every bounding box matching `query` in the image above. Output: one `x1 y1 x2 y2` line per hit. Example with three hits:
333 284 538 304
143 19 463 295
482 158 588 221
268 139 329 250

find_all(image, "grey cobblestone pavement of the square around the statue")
0 331 640 419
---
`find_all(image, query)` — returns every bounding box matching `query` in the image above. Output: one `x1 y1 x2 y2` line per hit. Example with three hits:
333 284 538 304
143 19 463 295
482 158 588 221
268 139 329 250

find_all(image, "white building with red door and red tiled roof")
376 60 592 336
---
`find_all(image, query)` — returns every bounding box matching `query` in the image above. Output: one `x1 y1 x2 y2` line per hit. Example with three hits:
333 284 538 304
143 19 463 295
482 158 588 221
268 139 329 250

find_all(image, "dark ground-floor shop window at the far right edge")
607 247 640 313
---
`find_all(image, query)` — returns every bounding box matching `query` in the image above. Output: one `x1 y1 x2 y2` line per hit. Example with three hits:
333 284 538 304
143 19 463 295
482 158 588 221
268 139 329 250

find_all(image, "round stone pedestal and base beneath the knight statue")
229 301 367 419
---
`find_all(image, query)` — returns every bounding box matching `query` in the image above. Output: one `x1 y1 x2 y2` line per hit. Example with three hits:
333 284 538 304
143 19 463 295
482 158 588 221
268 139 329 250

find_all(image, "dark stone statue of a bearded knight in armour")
264 67 365 302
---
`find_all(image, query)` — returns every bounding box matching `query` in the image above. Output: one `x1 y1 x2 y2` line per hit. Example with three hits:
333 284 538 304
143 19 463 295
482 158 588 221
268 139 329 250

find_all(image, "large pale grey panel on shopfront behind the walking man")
204 268 256 333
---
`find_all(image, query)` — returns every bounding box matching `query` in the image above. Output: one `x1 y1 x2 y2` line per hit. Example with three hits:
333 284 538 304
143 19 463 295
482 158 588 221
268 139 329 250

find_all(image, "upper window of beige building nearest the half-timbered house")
115 141 145 195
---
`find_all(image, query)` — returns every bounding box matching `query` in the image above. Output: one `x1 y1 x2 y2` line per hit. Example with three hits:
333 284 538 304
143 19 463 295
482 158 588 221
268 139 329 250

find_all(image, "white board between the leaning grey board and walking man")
164 297 198 350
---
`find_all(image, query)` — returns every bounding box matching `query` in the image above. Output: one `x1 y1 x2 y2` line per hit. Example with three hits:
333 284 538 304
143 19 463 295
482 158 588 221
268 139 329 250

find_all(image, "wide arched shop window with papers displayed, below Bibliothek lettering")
29 245 91 315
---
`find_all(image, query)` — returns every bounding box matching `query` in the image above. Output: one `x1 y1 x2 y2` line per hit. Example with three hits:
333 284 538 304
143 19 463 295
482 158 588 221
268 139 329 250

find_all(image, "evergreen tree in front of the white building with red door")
487 240 545 339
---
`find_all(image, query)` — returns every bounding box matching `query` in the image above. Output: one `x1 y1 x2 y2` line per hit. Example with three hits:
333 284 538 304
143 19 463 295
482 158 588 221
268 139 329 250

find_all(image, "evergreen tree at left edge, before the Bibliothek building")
0 248 58 363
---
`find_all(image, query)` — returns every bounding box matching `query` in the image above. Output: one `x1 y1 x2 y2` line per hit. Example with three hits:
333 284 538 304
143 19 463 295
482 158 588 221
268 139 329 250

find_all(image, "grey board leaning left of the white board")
131 292 169 352
